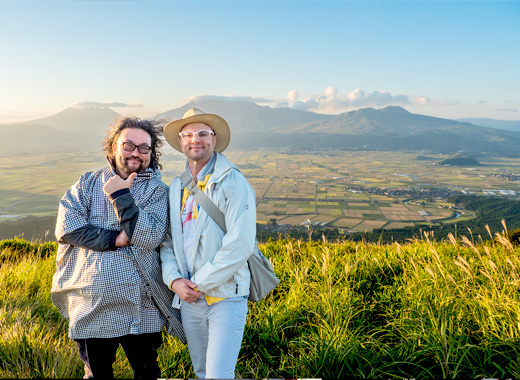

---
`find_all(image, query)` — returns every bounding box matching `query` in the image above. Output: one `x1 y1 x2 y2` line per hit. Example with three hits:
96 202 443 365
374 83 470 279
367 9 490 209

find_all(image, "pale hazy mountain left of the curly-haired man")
0 108 120 154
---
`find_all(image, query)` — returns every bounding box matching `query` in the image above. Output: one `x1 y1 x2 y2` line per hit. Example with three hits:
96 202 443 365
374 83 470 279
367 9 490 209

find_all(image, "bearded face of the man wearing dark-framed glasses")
112 128 152 179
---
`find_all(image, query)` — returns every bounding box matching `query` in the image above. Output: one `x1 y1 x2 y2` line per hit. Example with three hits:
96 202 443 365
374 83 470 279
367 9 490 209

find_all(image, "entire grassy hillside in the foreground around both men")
0 231 520 379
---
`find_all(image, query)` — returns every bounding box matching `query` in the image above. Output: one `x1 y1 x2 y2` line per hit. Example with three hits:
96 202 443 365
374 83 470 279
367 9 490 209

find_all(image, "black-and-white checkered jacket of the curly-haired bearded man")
51 167 186 342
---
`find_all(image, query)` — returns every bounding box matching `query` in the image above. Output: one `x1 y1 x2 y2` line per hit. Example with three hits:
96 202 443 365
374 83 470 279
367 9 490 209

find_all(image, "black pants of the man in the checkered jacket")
76 332 162 379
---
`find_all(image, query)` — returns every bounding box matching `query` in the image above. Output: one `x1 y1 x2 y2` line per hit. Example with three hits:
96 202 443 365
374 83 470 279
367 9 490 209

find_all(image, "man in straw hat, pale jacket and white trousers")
161 108 256 379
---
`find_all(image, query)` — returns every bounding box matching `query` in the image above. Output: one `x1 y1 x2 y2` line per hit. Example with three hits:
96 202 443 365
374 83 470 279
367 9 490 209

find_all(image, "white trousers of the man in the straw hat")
181 296 247 379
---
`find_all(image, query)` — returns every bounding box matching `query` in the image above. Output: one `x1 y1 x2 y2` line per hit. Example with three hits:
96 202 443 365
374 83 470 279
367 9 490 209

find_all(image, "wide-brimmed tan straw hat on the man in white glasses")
164 108 231 153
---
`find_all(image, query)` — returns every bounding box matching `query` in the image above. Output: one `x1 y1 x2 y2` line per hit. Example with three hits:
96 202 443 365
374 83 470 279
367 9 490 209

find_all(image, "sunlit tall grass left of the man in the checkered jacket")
0 239 81 378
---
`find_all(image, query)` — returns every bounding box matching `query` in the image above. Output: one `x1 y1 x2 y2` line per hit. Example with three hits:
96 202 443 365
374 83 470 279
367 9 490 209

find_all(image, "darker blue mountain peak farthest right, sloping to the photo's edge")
290 106 520 156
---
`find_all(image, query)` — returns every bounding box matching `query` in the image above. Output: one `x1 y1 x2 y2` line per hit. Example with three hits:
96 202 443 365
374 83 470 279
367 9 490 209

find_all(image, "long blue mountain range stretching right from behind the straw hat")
158 101 520 156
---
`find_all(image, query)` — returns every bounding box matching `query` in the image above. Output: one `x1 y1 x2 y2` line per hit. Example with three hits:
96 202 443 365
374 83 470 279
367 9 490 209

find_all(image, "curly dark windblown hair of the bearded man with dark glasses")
103 117 165 170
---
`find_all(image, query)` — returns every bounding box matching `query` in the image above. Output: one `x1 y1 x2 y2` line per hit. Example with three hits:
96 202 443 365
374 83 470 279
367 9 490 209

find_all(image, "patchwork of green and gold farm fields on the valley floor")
0 147 520 232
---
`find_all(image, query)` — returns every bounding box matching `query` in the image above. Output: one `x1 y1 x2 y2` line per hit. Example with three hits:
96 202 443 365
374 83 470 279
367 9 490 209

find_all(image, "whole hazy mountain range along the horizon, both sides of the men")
4 100 520 157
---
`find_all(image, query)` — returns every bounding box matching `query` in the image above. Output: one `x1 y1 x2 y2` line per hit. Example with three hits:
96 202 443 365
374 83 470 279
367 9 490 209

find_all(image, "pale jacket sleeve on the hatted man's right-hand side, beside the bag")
191 170 256 292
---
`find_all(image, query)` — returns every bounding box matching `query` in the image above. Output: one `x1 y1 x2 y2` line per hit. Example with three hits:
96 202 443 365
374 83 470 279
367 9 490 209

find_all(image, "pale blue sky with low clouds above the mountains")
0 0 520 123
